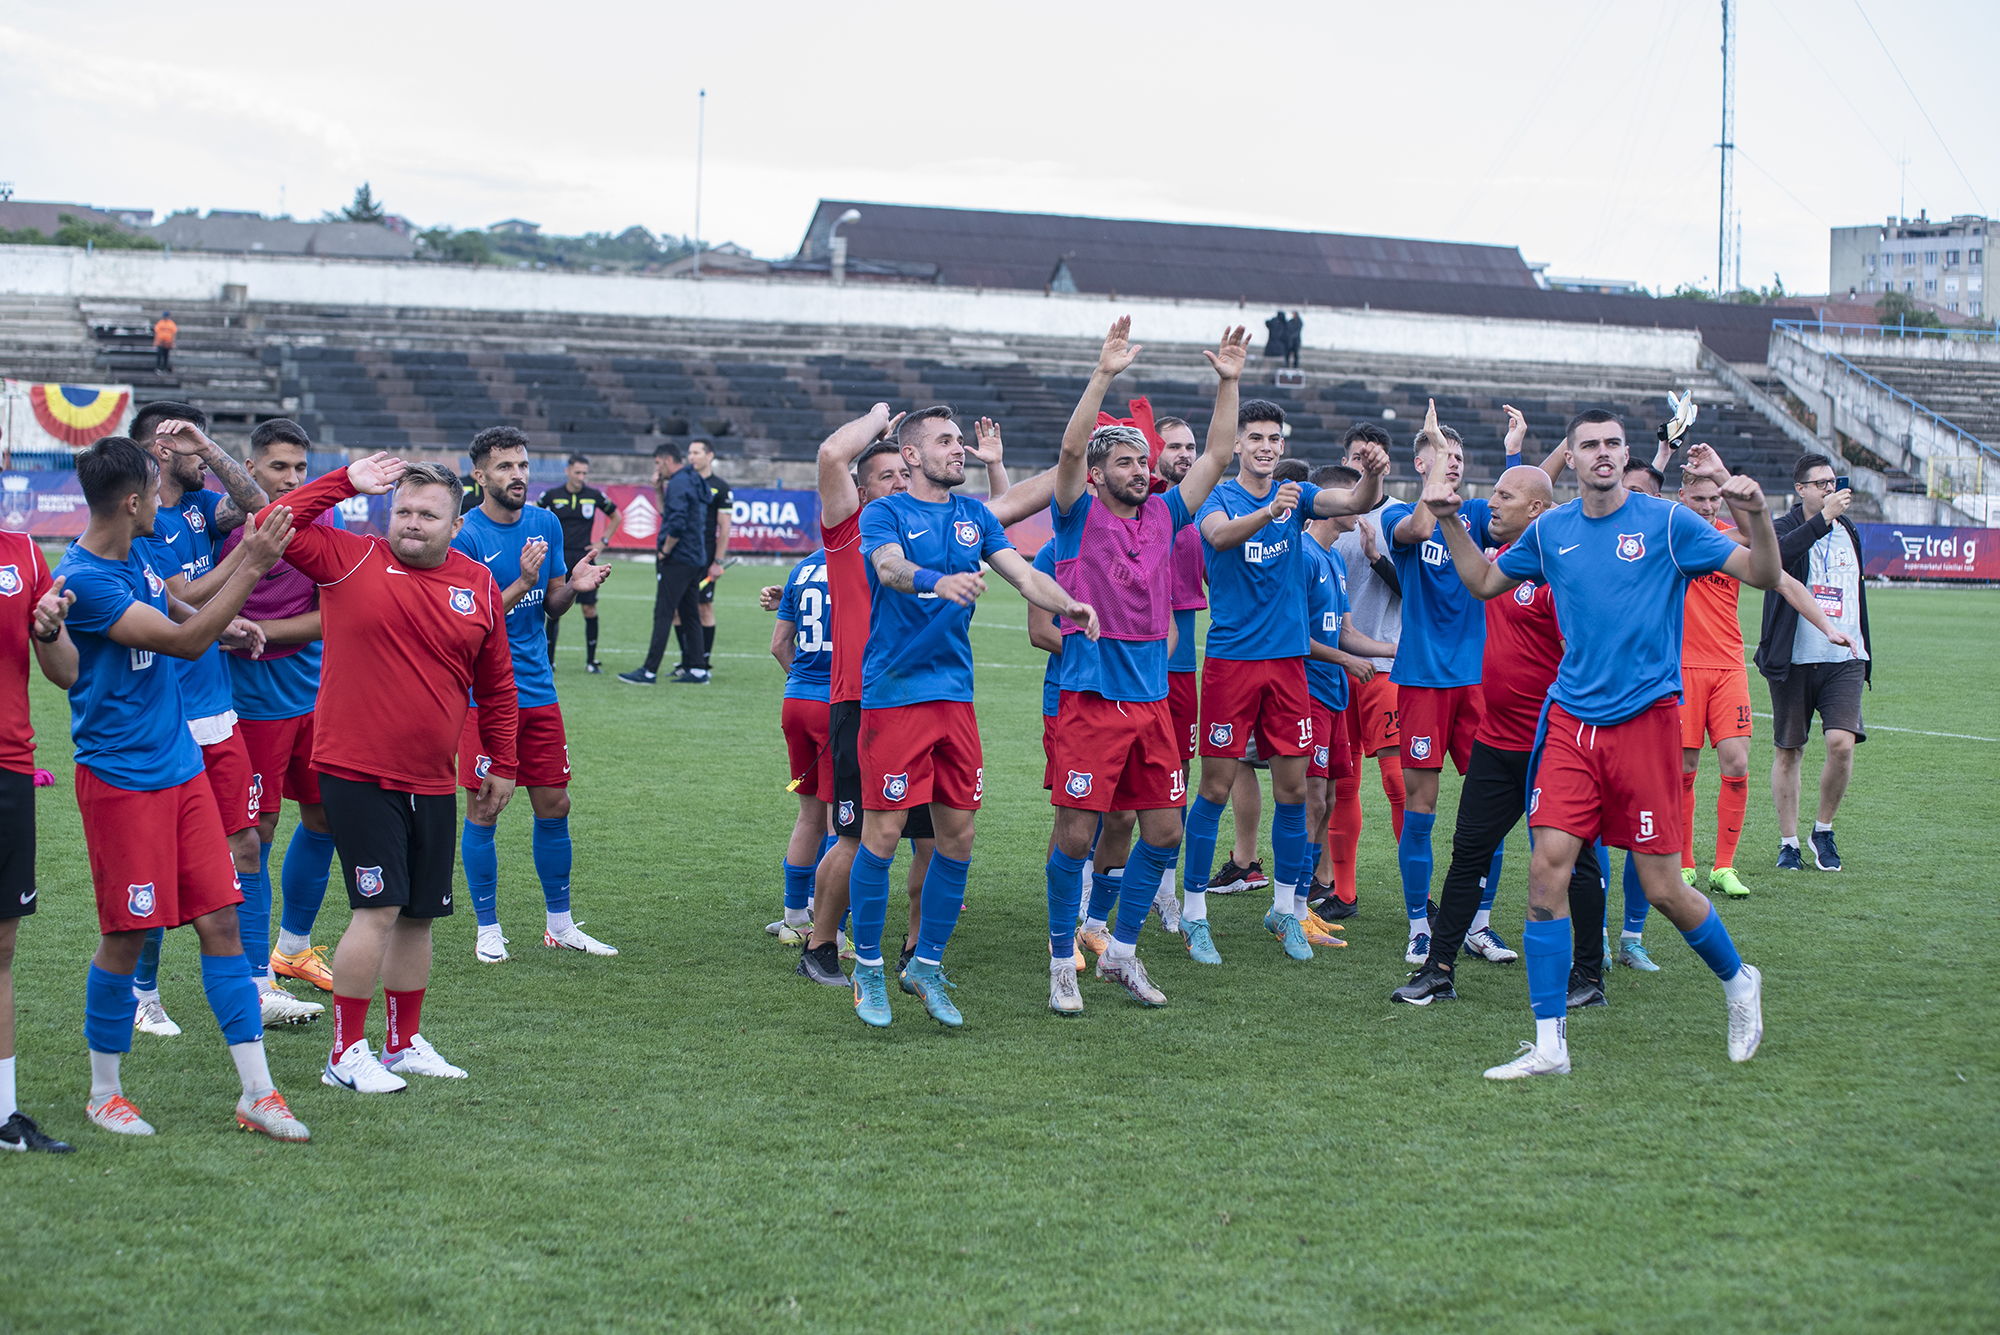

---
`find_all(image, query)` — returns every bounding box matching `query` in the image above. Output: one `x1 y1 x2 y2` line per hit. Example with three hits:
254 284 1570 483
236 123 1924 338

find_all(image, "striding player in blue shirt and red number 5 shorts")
1424 410 1782 1079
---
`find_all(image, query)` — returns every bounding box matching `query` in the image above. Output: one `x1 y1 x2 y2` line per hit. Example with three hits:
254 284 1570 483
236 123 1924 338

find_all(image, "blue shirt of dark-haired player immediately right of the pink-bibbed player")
1194 478 1320 662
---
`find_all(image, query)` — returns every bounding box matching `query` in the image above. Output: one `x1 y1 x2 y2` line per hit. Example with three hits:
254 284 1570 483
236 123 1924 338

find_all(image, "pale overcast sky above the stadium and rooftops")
0 0 2000 292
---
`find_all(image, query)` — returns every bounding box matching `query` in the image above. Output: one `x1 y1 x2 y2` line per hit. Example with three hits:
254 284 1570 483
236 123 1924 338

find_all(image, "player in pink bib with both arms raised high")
1048 316 1250 1015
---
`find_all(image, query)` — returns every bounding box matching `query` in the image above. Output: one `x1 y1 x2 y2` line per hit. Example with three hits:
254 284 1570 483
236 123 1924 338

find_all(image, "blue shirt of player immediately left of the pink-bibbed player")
862 492 1014 709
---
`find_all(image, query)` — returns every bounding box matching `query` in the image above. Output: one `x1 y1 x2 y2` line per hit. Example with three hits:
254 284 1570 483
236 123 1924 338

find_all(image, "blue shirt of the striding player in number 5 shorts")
1500 492 1736 727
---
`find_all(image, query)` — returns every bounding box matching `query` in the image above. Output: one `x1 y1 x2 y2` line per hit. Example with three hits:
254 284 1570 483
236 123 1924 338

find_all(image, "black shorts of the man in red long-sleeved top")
320 773 458 917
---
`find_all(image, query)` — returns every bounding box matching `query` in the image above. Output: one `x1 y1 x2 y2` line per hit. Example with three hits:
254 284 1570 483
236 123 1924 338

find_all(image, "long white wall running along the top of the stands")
0 246 1700 372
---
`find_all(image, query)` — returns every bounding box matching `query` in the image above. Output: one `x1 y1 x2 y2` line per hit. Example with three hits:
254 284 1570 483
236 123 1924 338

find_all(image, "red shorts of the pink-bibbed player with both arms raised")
1048 691 1188 811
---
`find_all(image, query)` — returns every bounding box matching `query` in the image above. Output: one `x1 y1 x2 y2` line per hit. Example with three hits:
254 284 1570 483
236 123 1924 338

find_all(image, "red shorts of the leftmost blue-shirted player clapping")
76 765 244 933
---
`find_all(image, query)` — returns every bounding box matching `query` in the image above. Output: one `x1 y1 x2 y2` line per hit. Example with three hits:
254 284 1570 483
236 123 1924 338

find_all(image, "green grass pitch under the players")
0 566 2000 1331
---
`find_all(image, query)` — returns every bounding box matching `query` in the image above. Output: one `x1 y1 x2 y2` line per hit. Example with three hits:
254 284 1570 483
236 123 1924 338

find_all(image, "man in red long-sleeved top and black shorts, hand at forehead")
254 454 516 1093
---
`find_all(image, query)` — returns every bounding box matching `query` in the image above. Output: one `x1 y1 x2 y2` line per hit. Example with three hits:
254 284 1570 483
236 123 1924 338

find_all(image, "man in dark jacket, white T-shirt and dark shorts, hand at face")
1756 454 1874 871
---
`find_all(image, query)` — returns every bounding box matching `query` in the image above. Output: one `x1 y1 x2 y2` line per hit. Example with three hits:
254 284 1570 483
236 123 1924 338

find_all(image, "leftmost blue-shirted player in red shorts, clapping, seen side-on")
56 436 308 1141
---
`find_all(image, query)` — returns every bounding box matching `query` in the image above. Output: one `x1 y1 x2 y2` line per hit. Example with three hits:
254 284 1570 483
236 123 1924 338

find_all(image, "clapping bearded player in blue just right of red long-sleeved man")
452 426 618 963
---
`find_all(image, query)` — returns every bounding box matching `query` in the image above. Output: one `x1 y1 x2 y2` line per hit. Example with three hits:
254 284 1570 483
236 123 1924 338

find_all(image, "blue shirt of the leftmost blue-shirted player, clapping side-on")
56 542 203 793
